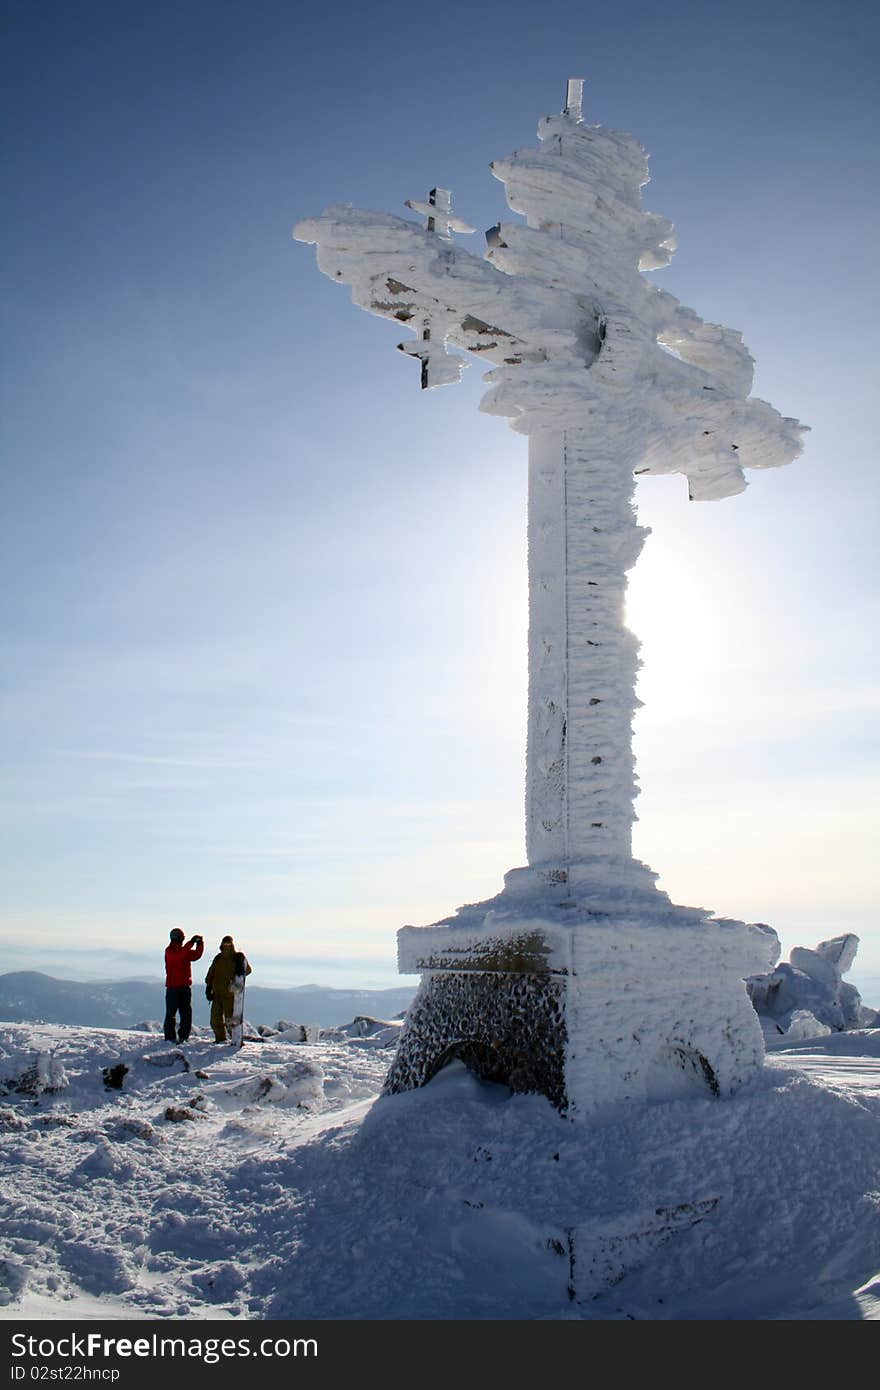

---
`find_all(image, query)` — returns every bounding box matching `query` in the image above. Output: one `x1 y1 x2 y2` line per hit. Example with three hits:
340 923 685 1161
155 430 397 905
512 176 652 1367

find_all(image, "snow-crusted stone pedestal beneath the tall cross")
385 872 779 1120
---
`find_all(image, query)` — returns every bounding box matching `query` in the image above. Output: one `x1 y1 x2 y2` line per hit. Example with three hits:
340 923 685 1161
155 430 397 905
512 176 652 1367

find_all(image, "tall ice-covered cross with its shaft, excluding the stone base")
295 78 802 883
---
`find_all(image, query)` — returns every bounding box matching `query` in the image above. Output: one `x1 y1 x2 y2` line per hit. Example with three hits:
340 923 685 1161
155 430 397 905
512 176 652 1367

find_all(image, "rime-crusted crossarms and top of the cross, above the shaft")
295 115 804 498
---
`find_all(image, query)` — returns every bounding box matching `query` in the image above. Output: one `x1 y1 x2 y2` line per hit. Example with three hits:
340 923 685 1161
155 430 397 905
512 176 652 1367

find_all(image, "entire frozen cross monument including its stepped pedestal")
295 79 802 1119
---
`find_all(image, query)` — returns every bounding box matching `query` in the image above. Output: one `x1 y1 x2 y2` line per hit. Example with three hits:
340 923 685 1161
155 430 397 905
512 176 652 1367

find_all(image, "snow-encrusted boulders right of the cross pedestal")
745 931 880 1038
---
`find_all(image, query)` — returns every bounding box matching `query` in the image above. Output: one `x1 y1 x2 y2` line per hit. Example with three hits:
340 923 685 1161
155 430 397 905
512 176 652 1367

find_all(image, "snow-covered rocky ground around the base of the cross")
0 1023 880 1319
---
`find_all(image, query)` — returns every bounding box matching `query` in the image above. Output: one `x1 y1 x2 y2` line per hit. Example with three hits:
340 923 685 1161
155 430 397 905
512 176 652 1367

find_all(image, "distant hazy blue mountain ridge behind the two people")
0 970 416 1029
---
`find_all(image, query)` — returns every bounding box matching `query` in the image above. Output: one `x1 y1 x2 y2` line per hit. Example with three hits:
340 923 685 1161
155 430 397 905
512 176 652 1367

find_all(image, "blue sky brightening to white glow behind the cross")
0 0 880 1004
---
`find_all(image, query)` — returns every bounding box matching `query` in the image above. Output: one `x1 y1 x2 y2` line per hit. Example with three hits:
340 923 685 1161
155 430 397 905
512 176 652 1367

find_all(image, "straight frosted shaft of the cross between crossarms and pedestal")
525 430 648 880
